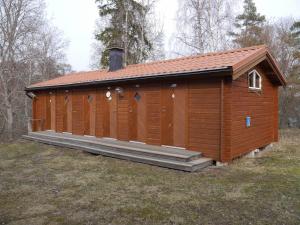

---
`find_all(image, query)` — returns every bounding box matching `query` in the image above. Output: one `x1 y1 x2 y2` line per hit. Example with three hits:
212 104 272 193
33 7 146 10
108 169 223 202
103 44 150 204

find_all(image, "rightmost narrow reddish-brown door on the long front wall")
161 85 175 146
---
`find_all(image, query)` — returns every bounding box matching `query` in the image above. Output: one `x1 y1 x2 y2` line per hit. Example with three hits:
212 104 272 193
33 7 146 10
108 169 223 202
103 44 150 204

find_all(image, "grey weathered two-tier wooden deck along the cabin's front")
23 131 213 172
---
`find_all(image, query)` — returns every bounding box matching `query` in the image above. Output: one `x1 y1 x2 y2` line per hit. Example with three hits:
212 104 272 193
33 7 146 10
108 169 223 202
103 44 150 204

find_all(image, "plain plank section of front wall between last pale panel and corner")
187 80 221 159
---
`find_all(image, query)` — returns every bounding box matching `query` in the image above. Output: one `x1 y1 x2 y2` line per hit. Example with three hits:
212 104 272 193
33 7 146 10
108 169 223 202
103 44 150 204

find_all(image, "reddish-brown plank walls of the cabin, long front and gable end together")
33 67 278 162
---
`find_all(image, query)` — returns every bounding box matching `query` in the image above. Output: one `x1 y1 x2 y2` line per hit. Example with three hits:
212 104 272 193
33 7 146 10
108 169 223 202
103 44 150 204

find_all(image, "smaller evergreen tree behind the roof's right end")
230 0 266 47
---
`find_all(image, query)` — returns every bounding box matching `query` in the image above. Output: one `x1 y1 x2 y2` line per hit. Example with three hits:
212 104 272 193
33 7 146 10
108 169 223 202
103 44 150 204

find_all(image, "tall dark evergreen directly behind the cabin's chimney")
96 0 152 67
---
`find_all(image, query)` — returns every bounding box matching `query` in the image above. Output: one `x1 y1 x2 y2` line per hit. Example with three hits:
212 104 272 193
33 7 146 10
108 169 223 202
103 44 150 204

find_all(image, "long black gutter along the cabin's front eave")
25 66 233 93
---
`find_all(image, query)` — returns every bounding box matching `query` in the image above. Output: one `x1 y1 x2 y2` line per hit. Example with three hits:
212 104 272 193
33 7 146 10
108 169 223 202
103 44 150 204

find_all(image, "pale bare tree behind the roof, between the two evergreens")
174 0 234 55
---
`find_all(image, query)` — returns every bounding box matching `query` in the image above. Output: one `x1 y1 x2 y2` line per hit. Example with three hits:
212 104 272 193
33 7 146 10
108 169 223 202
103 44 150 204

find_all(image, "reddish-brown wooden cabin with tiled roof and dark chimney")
26 46 286 162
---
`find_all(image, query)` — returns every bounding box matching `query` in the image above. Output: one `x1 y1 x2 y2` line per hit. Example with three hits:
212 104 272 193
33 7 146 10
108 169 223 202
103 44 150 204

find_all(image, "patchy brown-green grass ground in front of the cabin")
0 130 300 225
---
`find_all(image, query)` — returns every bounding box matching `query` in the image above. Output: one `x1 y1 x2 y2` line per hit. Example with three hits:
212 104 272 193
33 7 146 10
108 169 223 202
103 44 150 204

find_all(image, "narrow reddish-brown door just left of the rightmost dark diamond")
128 88 141 141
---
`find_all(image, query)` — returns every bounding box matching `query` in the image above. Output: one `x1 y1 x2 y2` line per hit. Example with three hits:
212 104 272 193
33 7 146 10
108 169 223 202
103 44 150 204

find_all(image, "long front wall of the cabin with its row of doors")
33 79 220 158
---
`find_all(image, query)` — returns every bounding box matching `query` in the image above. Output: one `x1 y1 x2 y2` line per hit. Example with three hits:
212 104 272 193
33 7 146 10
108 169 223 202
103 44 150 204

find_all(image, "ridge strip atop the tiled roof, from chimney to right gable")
127 45 267 67
